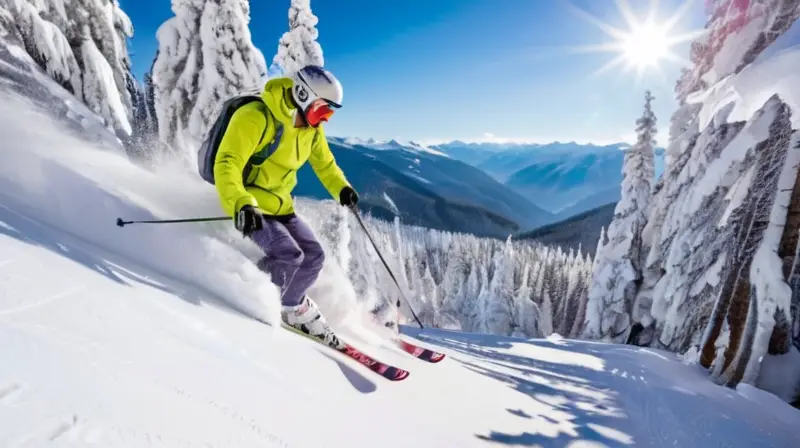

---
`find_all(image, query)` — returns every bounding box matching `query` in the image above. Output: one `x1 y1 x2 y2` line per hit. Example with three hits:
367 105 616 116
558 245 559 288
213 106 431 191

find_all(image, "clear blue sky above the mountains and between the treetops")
121 0 705 145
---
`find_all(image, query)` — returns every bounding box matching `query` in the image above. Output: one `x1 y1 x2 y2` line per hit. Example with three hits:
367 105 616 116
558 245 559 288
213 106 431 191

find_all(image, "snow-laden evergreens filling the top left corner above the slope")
0 0 133 140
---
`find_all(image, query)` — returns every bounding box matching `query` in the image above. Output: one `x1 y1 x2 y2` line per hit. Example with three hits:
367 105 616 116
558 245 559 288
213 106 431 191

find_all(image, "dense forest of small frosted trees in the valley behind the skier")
298 198 593 337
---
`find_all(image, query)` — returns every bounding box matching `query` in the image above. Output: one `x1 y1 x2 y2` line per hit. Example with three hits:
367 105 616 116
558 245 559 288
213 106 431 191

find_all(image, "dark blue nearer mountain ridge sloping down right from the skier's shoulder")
295 137 555 237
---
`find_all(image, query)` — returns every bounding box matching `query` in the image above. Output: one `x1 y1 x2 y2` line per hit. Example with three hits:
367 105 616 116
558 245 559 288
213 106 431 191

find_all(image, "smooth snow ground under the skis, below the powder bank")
0 209 800 448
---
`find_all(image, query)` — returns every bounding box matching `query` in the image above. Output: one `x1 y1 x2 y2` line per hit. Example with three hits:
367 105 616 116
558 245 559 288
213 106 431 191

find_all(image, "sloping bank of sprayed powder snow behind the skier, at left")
0 93 277 321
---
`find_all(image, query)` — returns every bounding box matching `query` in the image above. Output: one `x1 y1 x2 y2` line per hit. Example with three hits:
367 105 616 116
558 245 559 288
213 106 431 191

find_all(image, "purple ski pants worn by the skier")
252 215 325 306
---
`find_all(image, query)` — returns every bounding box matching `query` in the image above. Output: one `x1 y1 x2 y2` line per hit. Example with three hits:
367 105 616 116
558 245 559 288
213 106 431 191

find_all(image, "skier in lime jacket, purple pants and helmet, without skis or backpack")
213 65 358 348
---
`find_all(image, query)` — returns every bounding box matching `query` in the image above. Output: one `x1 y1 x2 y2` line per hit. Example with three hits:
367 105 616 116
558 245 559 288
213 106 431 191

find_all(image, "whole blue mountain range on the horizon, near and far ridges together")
295 137 663 240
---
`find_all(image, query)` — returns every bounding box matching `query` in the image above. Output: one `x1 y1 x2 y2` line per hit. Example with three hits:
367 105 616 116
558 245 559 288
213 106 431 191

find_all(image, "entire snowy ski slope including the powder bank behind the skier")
0 95 800 448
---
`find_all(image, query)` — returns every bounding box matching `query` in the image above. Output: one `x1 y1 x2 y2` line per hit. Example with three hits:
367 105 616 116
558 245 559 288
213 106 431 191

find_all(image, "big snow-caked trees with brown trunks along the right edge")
634 0 800 400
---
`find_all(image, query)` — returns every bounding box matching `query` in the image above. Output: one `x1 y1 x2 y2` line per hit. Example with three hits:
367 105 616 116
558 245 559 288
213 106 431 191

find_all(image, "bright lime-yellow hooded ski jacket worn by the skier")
214 78 350 216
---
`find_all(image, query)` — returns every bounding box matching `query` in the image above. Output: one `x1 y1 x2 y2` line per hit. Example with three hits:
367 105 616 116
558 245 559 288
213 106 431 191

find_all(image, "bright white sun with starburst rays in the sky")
568 0 705 77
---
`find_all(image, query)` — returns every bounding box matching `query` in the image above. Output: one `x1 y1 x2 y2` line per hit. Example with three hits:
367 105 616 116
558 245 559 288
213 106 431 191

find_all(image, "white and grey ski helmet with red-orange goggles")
292 65 344 127
